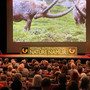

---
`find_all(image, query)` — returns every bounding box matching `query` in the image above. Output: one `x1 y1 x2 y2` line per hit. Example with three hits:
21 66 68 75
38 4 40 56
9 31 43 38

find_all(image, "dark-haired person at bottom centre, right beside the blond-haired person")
41 78 51 90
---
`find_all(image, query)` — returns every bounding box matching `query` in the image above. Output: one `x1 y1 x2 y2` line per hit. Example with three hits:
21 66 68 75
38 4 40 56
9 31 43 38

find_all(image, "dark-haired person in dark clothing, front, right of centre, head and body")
53 73 67 90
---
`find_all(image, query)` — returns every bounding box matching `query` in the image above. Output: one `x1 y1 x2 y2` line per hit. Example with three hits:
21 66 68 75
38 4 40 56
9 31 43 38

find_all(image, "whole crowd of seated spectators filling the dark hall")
0 58 90 90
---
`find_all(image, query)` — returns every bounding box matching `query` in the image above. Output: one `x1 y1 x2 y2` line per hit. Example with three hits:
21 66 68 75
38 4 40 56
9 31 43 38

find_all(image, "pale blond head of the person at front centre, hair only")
32 74 42 87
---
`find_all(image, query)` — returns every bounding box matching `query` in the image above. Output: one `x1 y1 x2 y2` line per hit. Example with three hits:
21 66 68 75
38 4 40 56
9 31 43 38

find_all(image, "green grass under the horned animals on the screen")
13 6 86 42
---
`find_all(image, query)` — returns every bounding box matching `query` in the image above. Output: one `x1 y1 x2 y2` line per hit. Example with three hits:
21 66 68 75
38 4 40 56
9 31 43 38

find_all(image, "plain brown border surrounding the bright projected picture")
7 0 90 54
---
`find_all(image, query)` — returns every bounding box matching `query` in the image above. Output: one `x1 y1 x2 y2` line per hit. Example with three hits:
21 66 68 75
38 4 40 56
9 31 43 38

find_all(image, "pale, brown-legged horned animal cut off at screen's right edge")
73 0 86 24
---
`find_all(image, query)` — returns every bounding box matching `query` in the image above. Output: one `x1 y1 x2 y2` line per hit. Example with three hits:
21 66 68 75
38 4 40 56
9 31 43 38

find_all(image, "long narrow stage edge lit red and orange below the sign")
0 54 90 59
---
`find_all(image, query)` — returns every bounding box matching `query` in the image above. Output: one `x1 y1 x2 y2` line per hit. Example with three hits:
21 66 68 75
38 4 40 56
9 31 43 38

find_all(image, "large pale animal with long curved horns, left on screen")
13 0 73 30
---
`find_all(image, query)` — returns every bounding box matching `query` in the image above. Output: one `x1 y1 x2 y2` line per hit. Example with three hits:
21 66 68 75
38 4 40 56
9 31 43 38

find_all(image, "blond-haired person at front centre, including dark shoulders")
28 74 42 90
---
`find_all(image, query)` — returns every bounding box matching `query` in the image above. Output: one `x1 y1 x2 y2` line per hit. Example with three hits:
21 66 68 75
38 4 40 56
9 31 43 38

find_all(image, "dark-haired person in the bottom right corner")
80 76 90 90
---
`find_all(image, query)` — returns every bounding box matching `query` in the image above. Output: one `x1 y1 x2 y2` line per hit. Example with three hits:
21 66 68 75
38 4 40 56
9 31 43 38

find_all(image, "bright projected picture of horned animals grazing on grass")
13 0 86 42
